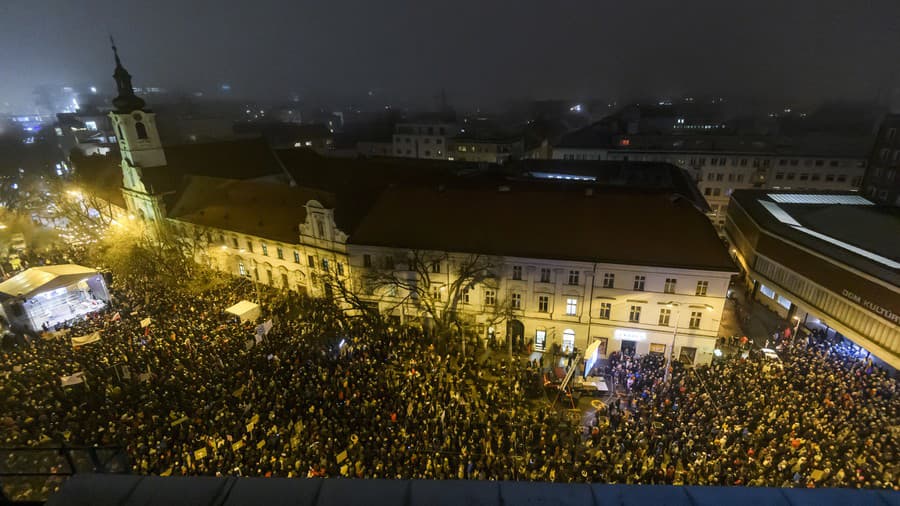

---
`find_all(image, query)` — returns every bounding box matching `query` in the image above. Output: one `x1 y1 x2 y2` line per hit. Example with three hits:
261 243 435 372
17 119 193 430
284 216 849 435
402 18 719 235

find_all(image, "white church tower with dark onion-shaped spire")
109 41 166 223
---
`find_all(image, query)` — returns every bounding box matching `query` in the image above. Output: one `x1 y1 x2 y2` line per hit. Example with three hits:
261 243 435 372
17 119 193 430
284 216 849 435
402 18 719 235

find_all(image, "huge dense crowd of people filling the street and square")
0 270 900 500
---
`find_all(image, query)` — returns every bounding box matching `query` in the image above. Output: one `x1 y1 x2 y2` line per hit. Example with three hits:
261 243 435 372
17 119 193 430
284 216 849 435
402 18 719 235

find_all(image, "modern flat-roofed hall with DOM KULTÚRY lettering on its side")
725 190 900 369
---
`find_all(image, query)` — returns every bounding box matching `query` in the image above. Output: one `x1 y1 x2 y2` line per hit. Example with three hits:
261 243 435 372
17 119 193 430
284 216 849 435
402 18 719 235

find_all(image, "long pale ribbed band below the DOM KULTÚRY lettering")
755 256 900 353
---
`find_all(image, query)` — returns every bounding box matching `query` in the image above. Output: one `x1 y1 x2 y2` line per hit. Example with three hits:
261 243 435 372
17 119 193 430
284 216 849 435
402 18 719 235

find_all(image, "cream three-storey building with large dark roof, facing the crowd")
348 184 736 363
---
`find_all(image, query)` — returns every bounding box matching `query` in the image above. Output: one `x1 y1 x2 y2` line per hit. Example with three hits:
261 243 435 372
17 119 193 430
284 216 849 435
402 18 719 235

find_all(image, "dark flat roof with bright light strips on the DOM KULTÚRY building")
731 190 900 286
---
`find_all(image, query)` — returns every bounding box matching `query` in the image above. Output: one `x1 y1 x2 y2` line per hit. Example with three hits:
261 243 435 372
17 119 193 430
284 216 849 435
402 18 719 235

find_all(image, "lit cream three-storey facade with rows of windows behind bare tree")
349 244 732 363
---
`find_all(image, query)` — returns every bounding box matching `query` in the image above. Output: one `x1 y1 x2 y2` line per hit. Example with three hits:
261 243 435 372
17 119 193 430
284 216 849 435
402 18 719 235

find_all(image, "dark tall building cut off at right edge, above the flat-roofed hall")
862 114 900 206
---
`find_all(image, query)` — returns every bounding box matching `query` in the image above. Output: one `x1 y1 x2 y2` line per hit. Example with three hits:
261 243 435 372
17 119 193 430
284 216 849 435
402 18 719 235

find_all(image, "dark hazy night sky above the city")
0 0 900 109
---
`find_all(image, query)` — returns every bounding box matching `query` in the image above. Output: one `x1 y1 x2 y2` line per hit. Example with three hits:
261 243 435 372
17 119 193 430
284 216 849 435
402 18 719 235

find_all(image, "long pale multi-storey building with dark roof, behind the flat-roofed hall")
553 128 871 227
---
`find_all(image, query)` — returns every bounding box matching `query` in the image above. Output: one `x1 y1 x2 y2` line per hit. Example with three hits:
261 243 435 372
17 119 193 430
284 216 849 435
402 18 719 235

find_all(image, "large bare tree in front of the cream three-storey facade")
363 250 507 352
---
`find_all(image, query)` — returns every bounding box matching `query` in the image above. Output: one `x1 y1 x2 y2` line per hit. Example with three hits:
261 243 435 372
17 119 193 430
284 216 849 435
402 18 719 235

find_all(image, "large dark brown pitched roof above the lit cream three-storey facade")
349 183 735 272
